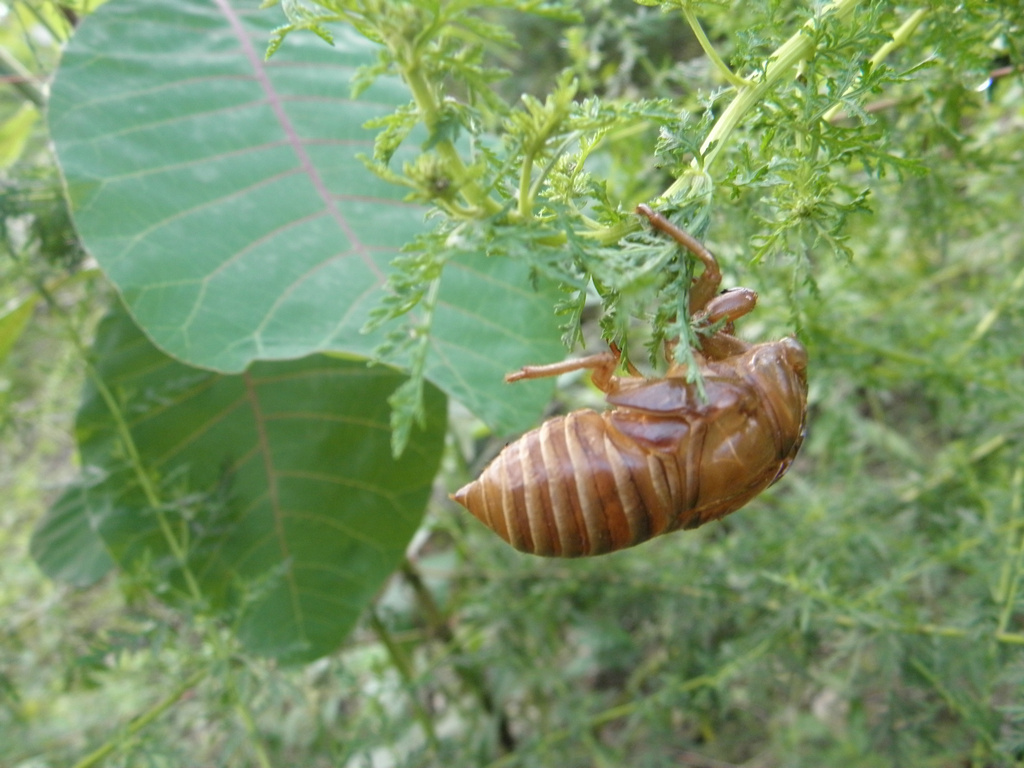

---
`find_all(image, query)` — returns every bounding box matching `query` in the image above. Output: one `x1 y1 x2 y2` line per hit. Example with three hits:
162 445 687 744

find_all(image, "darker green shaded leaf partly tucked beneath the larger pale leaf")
33 312 446 660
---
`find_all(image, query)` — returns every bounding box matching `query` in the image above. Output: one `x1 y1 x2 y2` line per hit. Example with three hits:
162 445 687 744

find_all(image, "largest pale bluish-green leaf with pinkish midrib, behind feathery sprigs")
49 0 562 431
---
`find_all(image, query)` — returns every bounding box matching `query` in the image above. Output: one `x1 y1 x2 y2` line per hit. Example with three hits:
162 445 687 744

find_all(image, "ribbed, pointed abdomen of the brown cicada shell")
453 411 699 557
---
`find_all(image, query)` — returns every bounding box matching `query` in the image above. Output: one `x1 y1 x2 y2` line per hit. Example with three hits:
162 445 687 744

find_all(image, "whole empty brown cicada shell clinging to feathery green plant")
452 206 807 557
